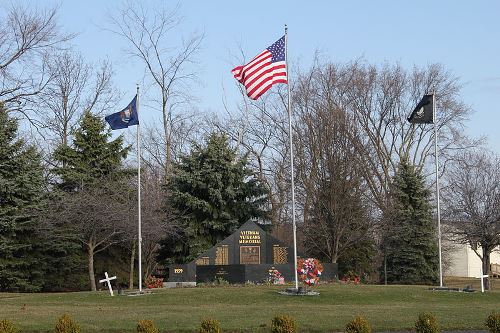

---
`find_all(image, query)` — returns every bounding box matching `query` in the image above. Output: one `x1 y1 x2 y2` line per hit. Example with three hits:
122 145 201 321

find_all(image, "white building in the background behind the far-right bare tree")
443 243 500 278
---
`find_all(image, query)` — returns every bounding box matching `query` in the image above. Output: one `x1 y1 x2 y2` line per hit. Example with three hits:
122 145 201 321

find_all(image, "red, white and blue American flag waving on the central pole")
231 36 288 99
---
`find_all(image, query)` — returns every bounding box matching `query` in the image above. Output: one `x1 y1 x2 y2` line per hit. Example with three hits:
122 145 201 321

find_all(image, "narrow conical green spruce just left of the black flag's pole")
382 160 439 284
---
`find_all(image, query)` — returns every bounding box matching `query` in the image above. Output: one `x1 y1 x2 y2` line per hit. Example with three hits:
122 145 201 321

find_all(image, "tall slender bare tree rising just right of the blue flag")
110 3 204 176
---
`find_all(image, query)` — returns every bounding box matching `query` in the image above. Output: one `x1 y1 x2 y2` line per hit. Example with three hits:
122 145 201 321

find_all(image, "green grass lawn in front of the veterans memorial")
0 284 500 332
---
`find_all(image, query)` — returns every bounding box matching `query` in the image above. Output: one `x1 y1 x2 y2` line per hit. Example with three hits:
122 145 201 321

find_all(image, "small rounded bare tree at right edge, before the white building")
442 151 500 288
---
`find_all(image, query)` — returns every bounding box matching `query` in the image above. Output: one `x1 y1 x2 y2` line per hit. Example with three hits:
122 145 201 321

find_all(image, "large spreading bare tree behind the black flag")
344 63 477 210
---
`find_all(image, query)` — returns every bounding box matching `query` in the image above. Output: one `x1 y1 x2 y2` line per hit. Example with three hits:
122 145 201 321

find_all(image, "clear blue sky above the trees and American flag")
51 0 500 153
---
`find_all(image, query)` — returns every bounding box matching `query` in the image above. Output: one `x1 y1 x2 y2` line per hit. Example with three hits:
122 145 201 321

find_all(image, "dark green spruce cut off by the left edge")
0 103 46 291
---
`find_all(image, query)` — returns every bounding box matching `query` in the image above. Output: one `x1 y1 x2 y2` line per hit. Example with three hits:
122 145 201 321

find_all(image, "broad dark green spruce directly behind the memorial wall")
159 133 268 262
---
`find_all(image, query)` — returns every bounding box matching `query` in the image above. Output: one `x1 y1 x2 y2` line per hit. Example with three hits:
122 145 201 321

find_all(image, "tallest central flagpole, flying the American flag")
285 24 299 290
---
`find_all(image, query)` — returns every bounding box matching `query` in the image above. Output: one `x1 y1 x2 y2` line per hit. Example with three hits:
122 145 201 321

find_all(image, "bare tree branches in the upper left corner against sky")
0 5 74 124
